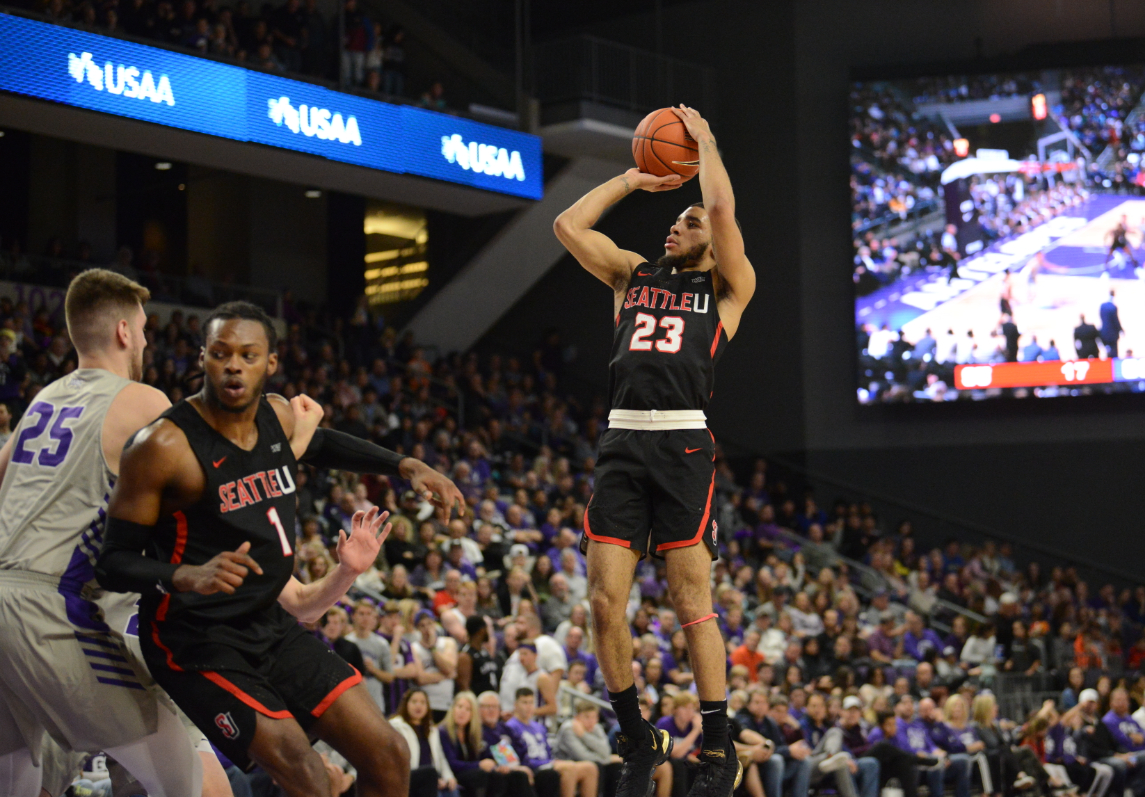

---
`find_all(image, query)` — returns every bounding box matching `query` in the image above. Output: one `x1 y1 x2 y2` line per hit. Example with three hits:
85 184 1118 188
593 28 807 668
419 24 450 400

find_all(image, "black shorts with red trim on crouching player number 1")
141 625 362 770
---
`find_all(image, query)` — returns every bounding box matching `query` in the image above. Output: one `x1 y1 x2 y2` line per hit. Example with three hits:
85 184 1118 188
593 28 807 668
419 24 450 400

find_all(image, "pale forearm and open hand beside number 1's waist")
278 506 393 623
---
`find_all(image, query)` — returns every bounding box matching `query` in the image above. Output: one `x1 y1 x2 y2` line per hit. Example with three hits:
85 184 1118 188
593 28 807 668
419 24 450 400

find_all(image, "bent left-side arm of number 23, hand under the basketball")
553 168 680 291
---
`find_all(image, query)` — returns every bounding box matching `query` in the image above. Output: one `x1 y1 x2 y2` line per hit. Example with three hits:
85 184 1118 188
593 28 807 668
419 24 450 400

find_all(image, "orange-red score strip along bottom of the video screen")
954 357 1145 390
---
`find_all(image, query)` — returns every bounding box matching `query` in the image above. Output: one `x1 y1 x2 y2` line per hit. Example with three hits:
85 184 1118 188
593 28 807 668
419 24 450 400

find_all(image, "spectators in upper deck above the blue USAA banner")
9 0 448 102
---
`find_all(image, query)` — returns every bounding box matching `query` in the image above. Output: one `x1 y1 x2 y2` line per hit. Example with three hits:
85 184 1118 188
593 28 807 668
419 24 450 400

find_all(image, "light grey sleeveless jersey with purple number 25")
0 369 131 590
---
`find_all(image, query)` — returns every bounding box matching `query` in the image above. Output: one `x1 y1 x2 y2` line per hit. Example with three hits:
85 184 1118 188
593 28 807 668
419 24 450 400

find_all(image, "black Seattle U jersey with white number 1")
140 397 298 669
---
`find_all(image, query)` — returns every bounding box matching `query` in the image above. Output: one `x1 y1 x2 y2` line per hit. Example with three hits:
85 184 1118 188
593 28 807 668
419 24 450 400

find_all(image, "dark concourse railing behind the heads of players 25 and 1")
0 253 282 317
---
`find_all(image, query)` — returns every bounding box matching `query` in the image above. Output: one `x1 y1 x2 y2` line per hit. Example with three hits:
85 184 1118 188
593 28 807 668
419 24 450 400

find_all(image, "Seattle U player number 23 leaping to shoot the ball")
554 105 756 797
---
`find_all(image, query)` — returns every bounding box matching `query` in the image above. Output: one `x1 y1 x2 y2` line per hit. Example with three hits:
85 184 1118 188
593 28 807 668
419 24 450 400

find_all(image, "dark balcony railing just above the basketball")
535 35 716 118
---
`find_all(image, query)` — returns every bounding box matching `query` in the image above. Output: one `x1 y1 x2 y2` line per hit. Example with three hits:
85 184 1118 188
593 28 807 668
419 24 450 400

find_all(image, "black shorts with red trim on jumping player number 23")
581 428 717 559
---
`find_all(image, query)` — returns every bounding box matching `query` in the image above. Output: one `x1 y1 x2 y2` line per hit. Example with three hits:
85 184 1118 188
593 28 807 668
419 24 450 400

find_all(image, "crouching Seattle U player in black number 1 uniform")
96 302 465 797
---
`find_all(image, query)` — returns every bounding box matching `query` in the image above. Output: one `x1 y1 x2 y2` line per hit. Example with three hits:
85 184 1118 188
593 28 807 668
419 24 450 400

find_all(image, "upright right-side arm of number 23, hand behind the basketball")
672 105 756 310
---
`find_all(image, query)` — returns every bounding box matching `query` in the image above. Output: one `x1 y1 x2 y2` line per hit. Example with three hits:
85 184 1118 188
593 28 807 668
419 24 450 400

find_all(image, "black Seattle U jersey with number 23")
608 263 727 410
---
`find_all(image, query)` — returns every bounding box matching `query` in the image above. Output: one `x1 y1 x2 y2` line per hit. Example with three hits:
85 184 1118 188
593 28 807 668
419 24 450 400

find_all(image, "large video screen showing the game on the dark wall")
850 65 1145 404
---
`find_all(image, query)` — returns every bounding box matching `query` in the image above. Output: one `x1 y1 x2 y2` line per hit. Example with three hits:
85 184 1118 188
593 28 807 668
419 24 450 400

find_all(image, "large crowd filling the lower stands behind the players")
0 273 1145 797
